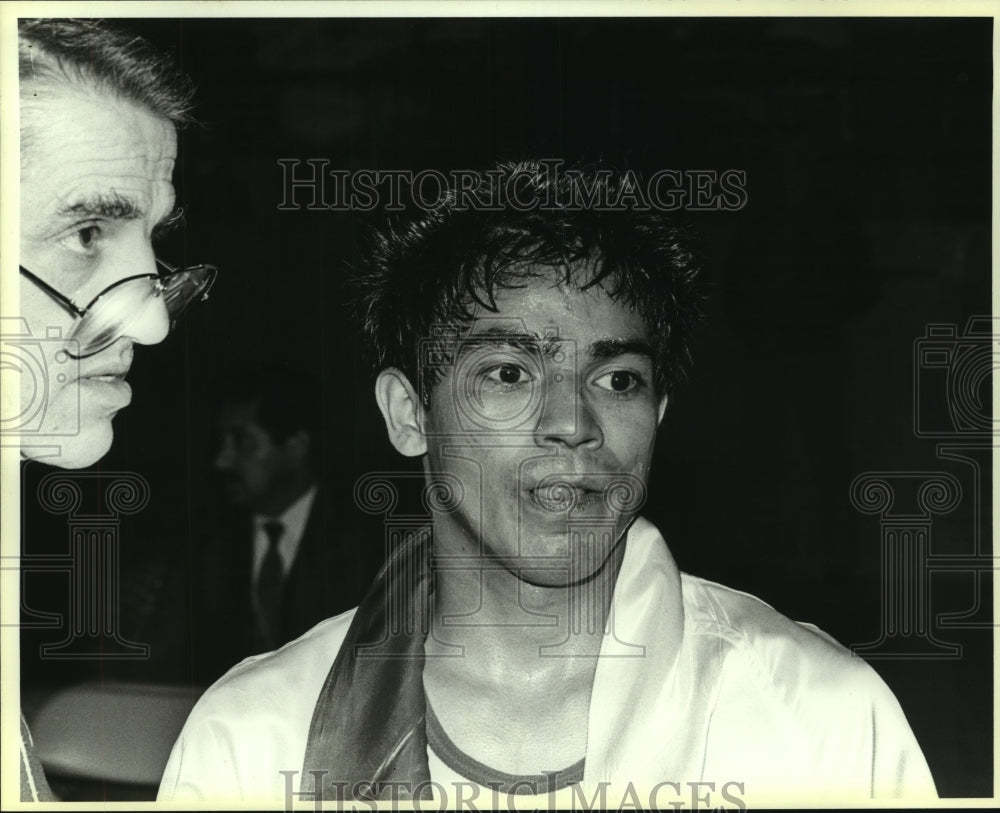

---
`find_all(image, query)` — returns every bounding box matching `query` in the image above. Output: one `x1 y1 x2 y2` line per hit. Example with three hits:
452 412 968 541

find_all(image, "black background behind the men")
22 18 996 796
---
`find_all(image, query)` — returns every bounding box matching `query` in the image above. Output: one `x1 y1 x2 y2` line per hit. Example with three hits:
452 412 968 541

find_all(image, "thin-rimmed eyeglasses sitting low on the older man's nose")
19 259 218 358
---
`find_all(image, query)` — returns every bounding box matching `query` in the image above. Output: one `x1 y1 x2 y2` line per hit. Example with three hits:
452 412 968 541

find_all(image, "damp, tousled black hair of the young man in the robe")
352 161 705 404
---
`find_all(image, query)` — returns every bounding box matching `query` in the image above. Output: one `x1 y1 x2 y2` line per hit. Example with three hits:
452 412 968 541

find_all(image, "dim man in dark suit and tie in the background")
192 365 382 684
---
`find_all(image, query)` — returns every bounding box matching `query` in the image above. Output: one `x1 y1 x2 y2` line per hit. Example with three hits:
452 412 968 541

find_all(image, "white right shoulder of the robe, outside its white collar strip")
681 575 935 798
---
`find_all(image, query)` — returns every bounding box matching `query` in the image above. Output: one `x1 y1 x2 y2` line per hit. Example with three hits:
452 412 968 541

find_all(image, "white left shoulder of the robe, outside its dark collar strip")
159 610 355 801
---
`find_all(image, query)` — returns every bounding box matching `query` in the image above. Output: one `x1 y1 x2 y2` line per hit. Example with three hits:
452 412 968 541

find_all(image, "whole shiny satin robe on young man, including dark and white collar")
159 519 935 806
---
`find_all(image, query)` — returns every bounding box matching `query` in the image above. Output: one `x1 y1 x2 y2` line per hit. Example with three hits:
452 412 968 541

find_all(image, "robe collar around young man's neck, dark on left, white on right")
302 518 684 802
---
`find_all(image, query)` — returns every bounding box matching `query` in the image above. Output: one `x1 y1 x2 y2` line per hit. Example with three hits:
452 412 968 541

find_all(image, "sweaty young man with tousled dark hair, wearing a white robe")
160 164 934 809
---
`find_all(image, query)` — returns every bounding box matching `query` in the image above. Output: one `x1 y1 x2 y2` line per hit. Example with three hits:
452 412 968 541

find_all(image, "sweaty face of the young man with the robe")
424 277 666 585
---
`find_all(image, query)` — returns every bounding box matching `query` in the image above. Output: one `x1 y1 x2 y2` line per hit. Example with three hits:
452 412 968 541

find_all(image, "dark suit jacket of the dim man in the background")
190 485 384 686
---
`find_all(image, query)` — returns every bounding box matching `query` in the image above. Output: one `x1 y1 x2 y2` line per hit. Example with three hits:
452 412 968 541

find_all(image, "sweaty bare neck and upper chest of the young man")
424 540 625 773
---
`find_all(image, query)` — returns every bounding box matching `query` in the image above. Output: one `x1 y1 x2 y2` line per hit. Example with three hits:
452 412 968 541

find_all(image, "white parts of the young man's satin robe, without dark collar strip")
159 519 936 809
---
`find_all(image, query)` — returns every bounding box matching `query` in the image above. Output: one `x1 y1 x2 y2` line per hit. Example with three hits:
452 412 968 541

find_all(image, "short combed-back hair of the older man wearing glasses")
17 19 194 127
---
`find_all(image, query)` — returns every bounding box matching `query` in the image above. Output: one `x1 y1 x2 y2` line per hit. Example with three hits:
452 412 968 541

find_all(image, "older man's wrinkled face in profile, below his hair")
20 86 177 468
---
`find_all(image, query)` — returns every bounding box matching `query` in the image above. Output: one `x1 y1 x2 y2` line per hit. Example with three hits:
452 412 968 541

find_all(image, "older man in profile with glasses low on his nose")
15 20 215 800
